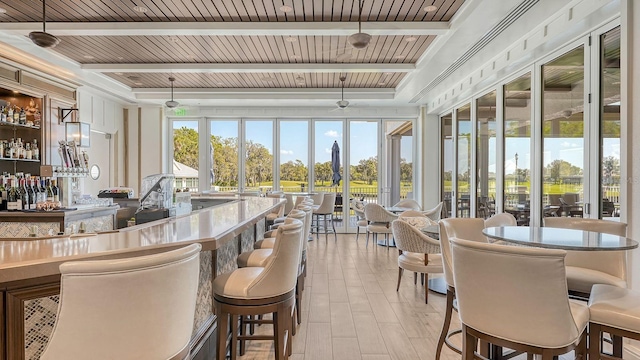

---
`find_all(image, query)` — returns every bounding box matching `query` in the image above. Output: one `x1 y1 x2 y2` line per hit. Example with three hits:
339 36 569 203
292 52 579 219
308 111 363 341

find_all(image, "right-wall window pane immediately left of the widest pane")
503 73 531 225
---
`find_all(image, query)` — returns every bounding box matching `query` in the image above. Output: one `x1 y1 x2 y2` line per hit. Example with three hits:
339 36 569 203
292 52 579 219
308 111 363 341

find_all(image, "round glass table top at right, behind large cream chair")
482 226 638 251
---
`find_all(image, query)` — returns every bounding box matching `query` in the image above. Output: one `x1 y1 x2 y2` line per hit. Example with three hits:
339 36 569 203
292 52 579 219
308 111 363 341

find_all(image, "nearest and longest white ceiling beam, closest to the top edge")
0 21 450 36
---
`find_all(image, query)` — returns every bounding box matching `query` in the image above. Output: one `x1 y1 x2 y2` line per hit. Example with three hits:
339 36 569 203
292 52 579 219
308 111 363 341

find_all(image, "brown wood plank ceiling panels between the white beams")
0 0 465 88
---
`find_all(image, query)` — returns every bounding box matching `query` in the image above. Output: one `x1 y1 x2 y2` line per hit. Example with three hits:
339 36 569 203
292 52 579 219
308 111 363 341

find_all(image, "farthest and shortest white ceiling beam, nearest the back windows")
132 88 395 101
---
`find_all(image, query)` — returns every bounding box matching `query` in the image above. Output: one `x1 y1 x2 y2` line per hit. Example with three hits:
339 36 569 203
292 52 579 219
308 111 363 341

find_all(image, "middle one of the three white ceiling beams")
82 63 415 73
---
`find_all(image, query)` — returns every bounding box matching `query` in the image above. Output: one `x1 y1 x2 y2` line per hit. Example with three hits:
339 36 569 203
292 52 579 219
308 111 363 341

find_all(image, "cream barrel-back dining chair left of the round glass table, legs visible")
391 220 442 304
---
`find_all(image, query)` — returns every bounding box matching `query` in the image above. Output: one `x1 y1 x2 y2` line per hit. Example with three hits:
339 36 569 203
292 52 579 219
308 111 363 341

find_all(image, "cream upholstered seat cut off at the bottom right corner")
589 285 640 360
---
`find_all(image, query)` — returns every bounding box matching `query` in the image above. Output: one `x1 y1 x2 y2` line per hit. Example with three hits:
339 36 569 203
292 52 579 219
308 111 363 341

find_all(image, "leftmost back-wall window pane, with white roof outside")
171 121 199 191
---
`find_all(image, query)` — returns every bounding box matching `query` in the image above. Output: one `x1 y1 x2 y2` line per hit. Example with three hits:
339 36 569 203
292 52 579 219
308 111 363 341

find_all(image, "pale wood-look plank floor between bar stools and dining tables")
238 235 573 360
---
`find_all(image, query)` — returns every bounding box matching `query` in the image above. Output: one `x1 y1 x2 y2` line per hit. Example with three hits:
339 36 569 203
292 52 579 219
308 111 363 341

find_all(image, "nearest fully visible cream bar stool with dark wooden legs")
213 219 304 360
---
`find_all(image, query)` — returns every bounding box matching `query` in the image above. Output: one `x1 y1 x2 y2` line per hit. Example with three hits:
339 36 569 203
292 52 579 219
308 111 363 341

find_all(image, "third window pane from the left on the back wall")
244 120 274 193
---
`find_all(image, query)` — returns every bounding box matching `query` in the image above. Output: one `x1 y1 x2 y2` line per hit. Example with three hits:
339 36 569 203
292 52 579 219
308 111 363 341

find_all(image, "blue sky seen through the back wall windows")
174 120 412 165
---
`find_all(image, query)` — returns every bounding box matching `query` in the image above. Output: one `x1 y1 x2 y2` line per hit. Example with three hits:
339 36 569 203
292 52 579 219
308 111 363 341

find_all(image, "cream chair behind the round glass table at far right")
544 217 627 299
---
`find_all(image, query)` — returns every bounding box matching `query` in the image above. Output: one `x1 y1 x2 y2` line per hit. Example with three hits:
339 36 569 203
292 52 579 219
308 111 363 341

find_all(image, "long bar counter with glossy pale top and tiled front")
0 197 285 360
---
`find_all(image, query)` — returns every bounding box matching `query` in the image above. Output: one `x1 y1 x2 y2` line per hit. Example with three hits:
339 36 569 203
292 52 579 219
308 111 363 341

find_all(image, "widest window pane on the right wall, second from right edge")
542 46 585 216
